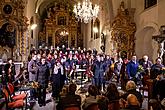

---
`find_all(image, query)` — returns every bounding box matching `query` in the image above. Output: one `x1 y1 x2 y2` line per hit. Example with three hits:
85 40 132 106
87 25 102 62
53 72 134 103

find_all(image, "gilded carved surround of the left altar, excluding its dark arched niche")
0 0 28 60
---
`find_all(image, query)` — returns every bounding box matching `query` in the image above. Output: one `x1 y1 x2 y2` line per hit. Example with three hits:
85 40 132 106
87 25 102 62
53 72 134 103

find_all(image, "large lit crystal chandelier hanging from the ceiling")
73 0 99 23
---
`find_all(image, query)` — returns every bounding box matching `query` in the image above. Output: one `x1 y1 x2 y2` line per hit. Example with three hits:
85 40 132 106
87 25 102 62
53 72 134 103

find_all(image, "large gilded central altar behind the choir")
39 0 83 47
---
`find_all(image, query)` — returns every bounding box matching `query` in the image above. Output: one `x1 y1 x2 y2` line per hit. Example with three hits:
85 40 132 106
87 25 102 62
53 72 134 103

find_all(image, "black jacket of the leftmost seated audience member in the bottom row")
56 93 81 110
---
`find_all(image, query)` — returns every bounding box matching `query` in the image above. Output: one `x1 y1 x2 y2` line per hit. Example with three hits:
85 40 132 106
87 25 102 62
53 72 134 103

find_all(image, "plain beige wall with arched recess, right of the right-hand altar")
135 0 165 61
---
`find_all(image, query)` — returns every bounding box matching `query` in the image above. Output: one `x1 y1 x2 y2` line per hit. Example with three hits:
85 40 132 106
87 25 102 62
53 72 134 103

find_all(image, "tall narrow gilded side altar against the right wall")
111 2 136 58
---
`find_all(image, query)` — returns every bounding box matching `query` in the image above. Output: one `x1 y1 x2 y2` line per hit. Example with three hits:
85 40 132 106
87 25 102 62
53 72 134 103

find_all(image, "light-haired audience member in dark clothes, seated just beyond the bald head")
121 81 143 105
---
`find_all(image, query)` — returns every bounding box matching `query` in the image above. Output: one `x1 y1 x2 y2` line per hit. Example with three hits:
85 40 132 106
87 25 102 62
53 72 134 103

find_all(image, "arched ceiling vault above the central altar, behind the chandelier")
35 0 114 29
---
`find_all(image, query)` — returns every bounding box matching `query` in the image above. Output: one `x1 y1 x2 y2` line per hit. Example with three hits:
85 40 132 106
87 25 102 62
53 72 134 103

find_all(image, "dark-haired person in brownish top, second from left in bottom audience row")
82 85 98 110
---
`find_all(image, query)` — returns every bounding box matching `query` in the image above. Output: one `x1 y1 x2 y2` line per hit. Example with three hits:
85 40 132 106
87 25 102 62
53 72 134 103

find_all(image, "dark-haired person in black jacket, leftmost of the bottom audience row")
56 84 81 110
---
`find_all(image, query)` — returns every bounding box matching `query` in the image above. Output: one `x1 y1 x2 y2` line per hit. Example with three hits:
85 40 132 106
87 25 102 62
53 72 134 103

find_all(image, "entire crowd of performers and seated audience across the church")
2 45 165 110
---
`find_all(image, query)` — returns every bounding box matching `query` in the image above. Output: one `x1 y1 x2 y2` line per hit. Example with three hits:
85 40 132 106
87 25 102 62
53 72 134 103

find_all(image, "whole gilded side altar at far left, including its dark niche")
0 0 28 60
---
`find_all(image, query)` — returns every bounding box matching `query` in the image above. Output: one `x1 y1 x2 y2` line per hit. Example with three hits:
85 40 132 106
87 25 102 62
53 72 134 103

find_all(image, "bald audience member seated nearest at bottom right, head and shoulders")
122 94 140 110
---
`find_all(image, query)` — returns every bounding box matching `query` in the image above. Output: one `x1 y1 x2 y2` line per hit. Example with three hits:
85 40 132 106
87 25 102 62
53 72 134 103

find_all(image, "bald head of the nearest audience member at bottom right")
127 94 140 106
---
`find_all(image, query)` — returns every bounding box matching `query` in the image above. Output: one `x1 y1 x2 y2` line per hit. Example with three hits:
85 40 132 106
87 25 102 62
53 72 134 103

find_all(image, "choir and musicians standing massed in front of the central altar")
28 46 112 106
